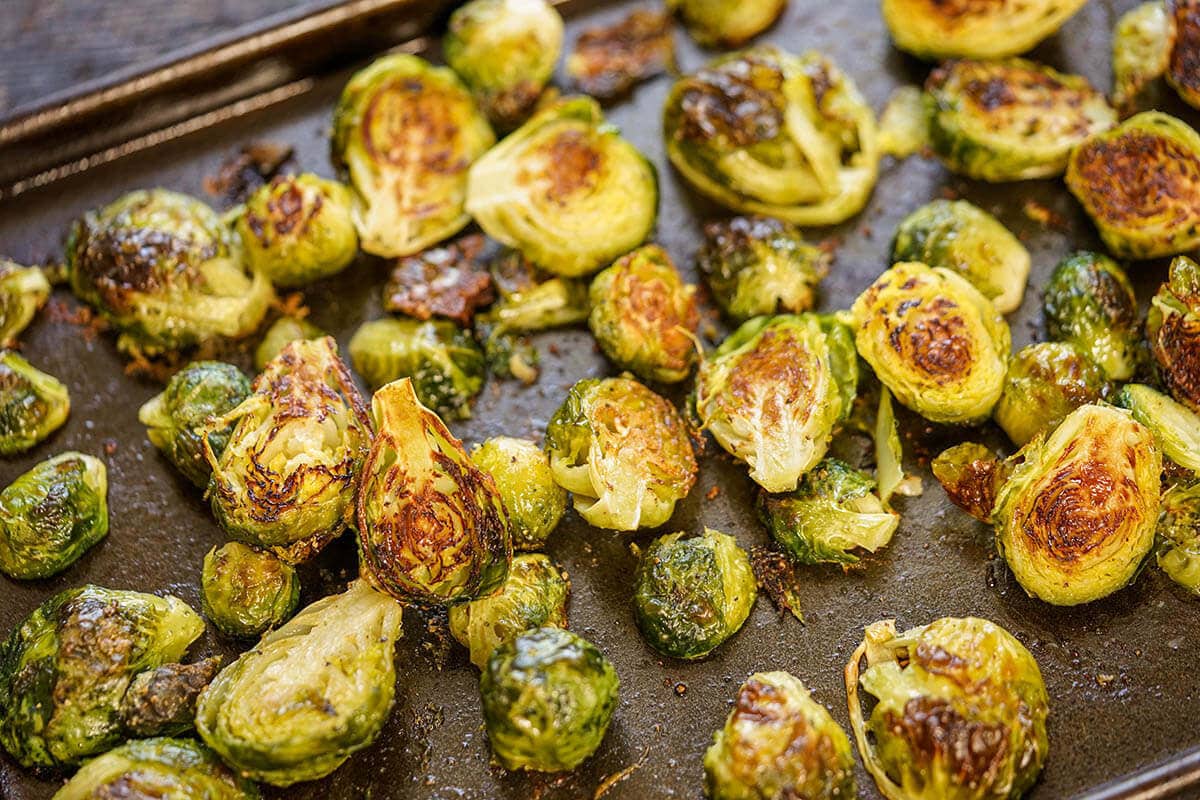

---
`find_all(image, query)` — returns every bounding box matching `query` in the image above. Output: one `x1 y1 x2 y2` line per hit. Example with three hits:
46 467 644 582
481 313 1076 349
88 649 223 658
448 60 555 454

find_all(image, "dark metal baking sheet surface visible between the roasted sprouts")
0 0 1200 800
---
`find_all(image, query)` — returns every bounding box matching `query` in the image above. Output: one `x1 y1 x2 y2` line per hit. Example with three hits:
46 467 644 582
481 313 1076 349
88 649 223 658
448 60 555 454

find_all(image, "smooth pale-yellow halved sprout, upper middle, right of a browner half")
467 97 659 277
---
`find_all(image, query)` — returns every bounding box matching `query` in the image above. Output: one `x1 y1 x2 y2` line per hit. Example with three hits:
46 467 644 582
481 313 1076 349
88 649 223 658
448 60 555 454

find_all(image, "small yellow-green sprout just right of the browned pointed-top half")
470 437 566 551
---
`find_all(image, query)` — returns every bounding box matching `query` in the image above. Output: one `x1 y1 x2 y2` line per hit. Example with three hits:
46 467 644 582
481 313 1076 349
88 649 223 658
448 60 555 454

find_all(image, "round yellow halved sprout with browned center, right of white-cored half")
852 261 1012 423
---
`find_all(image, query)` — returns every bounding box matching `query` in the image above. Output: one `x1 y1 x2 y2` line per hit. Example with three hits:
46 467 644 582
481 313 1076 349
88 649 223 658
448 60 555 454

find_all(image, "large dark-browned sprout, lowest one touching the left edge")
0 585 204 766
